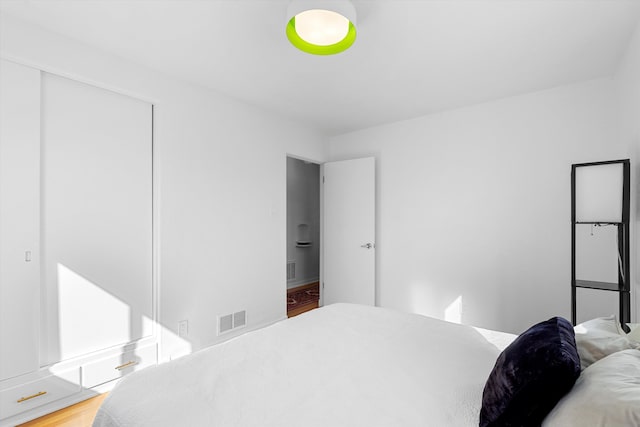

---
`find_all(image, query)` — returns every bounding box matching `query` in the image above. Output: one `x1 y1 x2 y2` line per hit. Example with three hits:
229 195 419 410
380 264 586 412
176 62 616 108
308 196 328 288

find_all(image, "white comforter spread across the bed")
94 304 513 427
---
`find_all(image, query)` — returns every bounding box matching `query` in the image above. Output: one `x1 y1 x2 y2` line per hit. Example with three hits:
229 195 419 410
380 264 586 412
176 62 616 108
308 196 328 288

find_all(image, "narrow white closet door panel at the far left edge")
0 60 40 380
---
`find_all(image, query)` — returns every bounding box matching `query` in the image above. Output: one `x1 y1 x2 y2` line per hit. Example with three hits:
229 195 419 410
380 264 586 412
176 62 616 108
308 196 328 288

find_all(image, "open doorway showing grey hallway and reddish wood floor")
287 157 320 317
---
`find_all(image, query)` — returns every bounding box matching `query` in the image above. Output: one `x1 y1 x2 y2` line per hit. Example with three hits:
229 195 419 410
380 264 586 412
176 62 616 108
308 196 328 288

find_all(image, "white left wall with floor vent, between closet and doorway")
0 16 325 359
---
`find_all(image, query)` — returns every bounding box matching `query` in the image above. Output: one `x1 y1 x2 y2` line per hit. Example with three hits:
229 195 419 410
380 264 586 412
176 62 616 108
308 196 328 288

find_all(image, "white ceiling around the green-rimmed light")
0 0 640 135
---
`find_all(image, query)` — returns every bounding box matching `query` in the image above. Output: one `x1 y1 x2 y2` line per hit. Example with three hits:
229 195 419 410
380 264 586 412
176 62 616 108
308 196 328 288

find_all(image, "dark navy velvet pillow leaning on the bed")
480 317 580 427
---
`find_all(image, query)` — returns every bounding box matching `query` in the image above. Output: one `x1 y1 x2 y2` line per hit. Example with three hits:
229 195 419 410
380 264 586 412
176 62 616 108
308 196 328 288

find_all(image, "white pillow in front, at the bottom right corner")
542 350 640 427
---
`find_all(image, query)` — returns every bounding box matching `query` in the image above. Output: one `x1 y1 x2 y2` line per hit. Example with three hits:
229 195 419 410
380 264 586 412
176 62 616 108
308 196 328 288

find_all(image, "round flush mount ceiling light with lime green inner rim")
287 0 356 55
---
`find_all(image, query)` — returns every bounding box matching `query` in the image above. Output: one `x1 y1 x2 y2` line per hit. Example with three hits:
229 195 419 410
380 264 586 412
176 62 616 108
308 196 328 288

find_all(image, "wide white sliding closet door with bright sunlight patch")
41 73 153 364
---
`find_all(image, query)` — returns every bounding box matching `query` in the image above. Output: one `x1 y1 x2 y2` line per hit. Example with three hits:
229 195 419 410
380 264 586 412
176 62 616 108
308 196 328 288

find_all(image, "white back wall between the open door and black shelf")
329 79 629 332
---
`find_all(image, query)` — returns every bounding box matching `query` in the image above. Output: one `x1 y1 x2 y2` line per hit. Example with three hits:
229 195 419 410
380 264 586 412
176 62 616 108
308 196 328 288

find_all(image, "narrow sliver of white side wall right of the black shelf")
614 19 640 328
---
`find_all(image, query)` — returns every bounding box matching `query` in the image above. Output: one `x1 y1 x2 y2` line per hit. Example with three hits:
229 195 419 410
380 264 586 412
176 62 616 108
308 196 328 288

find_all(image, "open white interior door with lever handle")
323 157 375 305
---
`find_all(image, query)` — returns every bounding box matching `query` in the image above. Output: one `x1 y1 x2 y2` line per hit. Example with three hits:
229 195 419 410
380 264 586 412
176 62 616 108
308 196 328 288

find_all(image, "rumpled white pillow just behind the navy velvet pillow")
574 316 640 369
